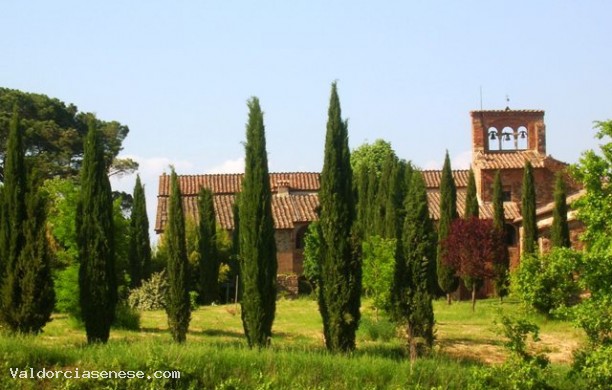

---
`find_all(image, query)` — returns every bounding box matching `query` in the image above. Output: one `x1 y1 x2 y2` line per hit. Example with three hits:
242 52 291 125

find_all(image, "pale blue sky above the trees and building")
0 0 612 239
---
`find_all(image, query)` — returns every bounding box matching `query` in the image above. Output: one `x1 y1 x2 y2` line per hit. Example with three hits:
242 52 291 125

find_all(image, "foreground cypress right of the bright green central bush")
392 171 437 360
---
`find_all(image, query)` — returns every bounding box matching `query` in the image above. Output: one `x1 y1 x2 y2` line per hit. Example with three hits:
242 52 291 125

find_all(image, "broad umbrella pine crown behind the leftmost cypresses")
0 88 138 181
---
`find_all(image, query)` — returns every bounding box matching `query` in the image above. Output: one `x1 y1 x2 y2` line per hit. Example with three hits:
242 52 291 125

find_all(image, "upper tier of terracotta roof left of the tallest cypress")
158 172 321 196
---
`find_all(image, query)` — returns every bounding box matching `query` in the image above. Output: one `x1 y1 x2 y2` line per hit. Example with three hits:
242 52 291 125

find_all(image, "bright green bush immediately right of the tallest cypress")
362 236 397 310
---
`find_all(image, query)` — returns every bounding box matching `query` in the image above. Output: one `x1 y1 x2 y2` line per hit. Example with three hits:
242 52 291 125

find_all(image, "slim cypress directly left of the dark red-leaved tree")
437 151 459 304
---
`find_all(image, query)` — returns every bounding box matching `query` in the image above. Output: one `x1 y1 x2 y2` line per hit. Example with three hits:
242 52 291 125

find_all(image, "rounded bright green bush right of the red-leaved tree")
513 248 582 316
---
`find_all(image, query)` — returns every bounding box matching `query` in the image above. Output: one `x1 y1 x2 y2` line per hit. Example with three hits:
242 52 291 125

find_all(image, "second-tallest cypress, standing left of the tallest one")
238 97 278 348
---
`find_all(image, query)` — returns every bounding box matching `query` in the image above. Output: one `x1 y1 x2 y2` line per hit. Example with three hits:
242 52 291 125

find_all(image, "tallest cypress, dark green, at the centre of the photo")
319 83 360 351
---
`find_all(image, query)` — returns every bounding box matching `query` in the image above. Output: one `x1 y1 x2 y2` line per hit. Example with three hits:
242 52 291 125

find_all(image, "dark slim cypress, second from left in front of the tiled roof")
198 187 219 305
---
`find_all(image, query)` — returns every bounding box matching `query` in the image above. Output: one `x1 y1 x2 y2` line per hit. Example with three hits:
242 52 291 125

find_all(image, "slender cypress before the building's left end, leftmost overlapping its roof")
164 168 191 343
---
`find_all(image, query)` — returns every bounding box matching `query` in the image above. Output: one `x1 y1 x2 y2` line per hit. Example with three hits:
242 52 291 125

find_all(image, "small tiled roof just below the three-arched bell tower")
474 150 567 169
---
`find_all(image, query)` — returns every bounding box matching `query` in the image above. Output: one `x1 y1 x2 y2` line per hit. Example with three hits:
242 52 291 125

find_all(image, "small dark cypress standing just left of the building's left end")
128 175 151 288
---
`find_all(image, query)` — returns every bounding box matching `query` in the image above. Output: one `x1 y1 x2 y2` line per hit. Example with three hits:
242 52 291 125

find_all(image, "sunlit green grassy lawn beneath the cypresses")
0 299 583 389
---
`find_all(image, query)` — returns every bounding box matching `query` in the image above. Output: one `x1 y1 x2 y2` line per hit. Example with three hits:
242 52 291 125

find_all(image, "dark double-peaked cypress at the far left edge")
0 110 55 333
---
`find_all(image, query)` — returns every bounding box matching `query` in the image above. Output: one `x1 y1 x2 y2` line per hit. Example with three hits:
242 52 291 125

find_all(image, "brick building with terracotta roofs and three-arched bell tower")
155 109 580 294
